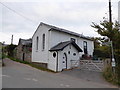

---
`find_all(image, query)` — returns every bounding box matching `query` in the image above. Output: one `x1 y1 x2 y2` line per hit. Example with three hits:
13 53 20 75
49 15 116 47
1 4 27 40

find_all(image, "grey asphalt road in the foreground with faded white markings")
2 59 116 88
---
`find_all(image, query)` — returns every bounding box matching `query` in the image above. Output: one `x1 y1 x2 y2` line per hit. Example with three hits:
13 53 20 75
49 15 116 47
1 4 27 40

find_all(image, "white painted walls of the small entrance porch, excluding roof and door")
48 45 79 71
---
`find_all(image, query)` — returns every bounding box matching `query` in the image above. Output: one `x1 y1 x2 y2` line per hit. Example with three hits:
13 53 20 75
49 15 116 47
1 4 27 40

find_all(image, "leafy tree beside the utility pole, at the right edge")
91 20 120 85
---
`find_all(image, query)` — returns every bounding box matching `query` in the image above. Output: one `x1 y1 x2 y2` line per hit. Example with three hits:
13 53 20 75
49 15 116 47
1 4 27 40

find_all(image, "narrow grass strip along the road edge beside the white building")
7 56 56 73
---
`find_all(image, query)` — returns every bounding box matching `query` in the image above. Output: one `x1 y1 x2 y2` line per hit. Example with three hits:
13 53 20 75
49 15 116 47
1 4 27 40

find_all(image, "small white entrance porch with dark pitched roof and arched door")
49 41 82 71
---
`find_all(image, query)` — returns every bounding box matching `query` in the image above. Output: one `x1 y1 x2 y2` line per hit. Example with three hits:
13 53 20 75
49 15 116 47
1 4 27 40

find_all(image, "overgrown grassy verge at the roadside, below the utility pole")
103 66 120 87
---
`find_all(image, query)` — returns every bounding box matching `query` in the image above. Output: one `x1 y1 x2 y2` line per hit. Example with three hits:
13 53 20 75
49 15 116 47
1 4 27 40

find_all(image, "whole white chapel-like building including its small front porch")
32 22 94 72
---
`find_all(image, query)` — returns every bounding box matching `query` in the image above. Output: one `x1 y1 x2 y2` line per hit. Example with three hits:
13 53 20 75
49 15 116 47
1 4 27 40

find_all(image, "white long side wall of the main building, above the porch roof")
49 31 94 56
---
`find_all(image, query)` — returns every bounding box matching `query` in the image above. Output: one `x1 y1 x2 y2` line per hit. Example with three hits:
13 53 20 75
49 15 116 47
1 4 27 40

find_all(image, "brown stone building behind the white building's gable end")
14 39 32 62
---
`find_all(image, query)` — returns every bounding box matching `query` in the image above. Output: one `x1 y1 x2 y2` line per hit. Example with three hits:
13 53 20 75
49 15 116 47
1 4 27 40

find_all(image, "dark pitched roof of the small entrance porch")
49 41 82 52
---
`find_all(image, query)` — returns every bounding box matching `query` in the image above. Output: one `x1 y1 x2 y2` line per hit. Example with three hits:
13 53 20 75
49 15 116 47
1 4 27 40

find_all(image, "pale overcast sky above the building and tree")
0 0 119 44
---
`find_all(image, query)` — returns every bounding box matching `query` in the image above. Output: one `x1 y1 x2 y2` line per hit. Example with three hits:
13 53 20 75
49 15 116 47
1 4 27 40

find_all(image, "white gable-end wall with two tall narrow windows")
32 24 50 63
